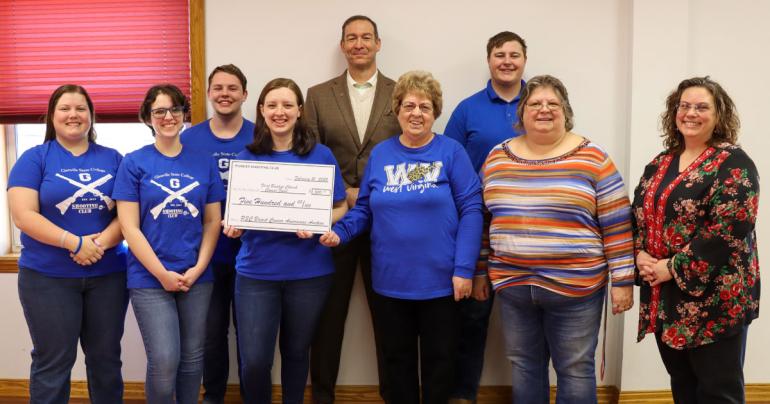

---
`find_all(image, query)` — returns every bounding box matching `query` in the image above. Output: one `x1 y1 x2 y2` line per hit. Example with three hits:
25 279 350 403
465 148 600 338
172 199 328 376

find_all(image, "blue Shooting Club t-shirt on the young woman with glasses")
112 144 225 288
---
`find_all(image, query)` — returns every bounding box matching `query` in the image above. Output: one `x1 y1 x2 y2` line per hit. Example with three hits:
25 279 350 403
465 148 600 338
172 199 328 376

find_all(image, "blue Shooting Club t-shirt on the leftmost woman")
8 140 126 278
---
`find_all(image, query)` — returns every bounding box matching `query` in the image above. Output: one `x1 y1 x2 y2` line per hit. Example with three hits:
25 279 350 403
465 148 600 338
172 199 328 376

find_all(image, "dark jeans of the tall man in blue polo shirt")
452 278 495 401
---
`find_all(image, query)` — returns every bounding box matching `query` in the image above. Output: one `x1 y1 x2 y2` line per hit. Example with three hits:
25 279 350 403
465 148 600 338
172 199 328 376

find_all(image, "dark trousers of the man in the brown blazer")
310 234 387 403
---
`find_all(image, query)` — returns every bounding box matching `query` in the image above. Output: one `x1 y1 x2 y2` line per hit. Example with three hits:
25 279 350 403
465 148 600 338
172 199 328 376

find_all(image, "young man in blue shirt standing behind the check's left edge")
182 64 254 404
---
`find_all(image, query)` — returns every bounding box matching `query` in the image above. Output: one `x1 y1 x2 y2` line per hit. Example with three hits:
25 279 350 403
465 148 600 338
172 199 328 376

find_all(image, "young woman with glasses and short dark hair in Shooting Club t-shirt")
113 84 225 404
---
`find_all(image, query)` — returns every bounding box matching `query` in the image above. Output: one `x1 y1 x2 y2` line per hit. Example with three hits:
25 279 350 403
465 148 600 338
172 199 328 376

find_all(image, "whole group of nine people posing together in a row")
8 11 759 404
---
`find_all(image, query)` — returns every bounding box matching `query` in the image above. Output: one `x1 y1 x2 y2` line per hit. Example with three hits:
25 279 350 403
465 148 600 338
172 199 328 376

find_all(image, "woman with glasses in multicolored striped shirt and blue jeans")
482 76 634 403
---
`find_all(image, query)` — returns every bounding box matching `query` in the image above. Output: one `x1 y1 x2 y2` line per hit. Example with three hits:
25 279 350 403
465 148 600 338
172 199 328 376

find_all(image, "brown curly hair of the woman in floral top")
660 76 741 153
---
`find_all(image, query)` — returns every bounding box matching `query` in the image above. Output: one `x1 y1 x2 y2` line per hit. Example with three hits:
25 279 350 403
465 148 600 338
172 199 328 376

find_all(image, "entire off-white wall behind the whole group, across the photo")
0 0 770 390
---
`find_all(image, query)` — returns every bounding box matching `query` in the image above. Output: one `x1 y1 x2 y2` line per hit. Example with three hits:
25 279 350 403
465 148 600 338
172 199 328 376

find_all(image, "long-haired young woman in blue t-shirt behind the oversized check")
219 78 347 403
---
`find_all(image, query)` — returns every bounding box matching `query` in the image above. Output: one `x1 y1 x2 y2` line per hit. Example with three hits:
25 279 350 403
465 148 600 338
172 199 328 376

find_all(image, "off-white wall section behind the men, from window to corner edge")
206 0 630 385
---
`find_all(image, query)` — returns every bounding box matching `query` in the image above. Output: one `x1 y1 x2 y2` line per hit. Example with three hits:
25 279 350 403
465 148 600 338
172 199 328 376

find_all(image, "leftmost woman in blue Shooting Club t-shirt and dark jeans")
8 85 128 404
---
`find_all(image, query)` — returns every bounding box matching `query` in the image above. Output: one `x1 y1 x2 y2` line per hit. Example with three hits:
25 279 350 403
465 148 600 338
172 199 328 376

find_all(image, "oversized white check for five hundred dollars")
225 160 334 233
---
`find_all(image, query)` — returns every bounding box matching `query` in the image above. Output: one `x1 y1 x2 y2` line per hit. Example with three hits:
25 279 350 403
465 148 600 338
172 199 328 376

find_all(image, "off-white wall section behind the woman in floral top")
622 0 770 391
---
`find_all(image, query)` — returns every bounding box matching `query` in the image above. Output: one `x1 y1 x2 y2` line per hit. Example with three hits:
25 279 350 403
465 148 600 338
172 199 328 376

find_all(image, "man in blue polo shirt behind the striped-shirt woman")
444 31 527 404
